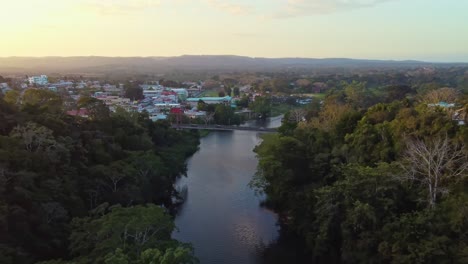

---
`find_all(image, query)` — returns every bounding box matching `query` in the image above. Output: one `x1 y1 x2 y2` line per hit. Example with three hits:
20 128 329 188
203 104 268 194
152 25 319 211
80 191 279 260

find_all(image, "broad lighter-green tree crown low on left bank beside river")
70 204 175 260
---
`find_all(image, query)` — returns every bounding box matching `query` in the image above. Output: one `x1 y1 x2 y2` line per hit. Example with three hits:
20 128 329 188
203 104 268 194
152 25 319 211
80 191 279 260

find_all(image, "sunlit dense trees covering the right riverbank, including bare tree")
252 82 468 263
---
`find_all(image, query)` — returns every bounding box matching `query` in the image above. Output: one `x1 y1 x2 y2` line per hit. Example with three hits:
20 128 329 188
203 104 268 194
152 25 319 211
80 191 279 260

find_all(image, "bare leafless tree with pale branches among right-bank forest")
401 135 468 208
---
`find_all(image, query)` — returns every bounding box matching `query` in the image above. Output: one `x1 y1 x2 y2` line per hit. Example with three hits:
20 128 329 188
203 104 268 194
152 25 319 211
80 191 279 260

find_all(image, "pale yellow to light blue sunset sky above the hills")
0 0 468 62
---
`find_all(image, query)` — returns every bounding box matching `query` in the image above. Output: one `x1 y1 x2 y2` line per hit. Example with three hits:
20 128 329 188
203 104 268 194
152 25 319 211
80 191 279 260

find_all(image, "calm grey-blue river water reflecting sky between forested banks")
173 118 288 264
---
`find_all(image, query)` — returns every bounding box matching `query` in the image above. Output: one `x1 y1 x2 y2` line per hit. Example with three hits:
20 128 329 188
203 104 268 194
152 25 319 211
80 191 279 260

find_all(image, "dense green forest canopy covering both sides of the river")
0 66 468 263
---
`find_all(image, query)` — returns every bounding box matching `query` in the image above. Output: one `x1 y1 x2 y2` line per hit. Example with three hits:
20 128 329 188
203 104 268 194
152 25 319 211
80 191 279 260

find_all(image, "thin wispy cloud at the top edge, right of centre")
273 0 395 18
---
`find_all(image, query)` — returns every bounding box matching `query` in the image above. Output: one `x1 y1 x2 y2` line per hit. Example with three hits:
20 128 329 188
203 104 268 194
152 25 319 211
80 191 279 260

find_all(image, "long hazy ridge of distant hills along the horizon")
0 55 467 74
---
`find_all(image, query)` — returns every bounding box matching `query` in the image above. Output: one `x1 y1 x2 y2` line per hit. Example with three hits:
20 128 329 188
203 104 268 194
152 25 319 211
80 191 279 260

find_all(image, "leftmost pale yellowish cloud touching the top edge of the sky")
81 0 161 15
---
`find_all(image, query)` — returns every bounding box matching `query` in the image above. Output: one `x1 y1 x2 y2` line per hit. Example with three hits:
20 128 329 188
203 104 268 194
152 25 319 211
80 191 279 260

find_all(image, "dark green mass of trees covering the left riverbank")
0 89 199 263
